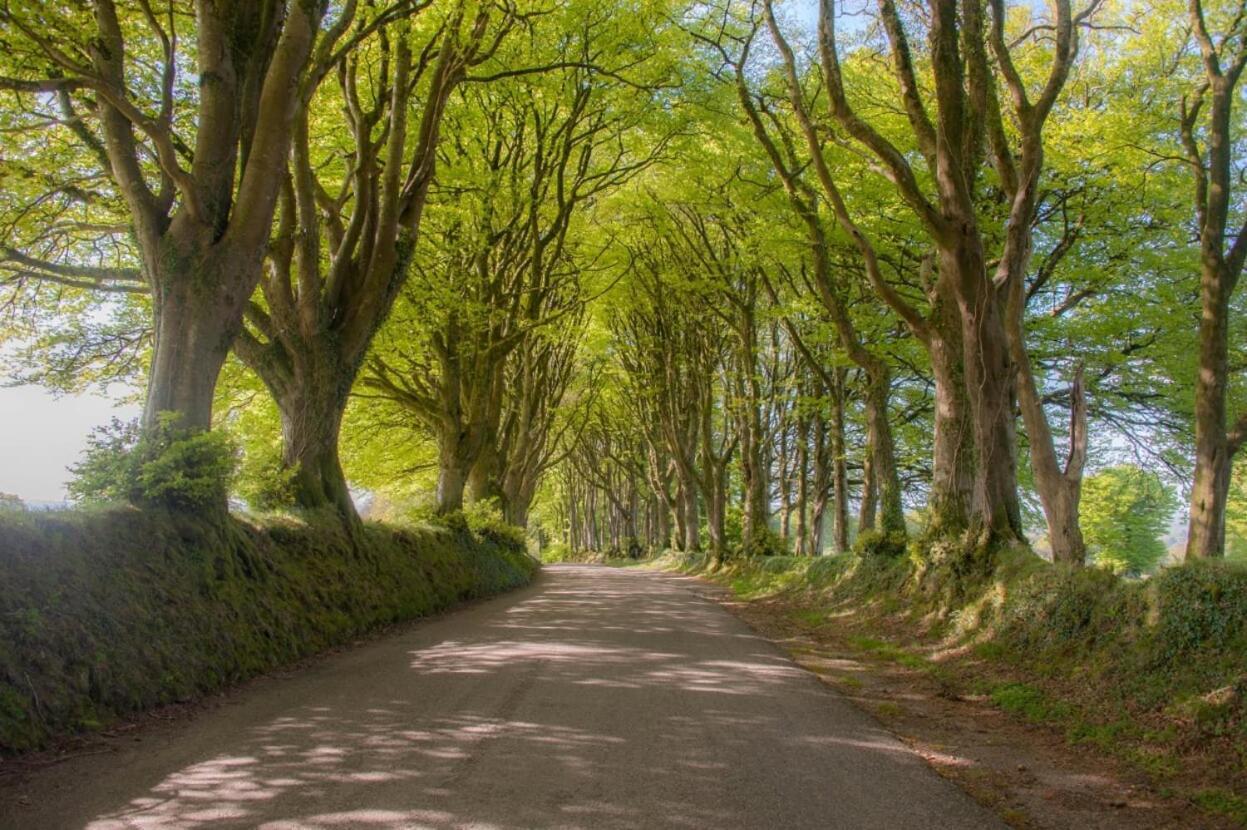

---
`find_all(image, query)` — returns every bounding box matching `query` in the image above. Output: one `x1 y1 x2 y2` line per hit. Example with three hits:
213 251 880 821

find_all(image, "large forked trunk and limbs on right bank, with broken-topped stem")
767 0 1099 560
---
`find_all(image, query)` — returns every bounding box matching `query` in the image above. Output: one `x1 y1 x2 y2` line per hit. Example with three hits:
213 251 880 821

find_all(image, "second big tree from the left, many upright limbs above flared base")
234 0 516 521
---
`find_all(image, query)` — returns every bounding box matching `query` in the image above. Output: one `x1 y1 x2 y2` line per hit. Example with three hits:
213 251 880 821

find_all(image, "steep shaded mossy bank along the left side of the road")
0 508 536 753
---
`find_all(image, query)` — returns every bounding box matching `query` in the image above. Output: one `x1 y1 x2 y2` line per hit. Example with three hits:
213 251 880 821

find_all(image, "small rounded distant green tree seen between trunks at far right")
1080 465 1177 576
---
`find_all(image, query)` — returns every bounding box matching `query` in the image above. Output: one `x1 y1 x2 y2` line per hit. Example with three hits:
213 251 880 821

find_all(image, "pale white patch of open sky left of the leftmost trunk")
0 386 138 503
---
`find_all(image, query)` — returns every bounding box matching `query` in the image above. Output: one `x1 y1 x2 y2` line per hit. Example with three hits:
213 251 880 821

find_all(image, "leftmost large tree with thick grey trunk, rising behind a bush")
0 0 361 430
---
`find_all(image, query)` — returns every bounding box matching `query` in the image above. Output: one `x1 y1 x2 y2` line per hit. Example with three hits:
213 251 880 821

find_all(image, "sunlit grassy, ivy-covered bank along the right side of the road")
660 551 1247 825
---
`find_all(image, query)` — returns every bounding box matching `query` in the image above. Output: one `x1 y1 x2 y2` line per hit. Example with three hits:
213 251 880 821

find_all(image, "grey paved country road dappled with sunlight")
0 566 1003 830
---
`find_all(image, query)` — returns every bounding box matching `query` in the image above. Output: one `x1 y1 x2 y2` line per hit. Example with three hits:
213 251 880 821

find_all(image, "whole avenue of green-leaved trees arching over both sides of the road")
0 0 1247 575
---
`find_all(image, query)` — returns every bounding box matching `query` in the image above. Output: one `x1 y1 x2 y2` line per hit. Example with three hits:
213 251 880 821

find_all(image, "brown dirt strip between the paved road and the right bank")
702 581 1238 830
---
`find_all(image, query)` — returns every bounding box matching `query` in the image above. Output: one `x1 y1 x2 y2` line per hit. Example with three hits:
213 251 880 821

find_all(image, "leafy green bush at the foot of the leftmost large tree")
69 417 238 510
